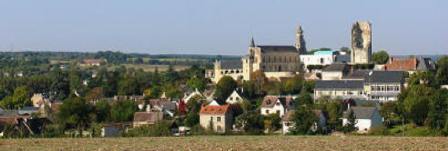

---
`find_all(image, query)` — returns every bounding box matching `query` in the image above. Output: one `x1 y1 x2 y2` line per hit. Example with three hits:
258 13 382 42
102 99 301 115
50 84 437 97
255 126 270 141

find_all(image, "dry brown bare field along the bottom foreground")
0 136 448 151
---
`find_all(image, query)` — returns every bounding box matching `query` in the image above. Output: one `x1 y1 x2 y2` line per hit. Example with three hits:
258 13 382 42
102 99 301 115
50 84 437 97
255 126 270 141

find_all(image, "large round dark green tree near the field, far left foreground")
57 97 95 136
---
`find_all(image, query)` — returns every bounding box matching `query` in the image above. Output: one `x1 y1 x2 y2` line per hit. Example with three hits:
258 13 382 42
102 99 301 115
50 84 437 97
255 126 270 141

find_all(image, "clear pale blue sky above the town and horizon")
0 0 448 55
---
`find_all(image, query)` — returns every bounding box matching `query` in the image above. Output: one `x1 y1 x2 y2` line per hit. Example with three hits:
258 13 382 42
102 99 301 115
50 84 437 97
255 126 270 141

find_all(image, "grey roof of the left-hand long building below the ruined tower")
315 80 364 90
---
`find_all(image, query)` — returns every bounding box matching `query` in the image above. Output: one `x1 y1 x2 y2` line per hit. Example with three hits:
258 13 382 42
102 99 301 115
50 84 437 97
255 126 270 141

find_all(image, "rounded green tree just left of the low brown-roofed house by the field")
110 101 138 122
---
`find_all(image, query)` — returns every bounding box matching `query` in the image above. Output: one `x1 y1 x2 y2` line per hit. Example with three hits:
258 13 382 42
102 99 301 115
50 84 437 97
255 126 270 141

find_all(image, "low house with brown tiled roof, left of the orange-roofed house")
132 111 163 127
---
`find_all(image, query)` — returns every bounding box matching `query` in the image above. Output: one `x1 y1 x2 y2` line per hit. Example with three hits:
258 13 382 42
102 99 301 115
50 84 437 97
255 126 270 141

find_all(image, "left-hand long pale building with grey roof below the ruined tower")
314 80 366 100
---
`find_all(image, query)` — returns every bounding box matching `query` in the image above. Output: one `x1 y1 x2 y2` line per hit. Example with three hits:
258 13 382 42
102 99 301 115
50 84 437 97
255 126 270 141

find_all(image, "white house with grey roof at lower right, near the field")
342 107 383 133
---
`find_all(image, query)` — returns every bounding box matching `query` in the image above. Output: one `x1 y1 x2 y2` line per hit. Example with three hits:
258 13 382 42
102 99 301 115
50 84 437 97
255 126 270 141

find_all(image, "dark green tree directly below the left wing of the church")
214 76 237 103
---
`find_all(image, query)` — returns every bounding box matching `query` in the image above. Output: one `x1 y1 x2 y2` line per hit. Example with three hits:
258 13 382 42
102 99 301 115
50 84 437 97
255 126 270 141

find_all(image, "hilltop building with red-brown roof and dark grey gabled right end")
384 57 436 74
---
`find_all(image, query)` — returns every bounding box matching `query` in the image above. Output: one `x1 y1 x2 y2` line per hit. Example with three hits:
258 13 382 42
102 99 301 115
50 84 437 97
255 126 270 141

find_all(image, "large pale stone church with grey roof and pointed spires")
207 26 306 83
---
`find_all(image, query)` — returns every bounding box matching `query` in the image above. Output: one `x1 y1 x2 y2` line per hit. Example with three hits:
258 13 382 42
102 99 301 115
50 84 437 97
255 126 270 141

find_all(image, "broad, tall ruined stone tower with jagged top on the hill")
351 21 372 64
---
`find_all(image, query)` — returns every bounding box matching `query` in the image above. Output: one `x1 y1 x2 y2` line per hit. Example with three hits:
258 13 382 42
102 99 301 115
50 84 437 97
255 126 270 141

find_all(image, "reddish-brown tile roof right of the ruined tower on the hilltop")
384 58 418 71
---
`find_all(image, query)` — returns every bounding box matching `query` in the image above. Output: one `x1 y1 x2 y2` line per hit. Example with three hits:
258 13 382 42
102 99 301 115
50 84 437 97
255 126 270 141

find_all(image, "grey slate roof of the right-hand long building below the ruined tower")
365 71 404 83
